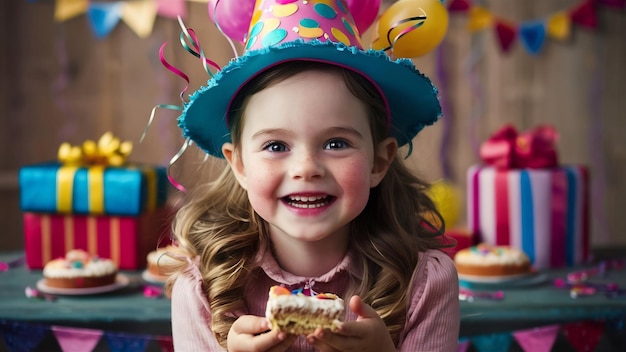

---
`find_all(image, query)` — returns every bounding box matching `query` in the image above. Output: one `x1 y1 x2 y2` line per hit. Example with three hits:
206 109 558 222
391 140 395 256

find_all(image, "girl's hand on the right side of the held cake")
307 296 396 352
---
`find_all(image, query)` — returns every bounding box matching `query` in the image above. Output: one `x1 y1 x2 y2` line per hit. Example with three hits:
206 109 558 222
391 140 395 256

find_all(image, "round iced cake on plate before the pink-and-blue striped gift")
454 243 531 276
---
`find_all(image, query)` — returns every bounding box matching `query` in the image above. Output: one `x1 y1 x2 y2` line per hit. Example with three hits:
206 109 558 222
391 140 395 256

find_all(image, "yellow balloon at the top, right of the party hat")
372 0 448 58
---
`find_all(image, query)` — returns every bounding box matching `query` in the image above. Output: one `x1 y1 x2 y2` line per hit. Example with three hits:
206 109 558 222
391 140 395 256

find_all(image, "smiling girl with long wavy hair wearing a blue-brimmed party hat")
158 0 459 351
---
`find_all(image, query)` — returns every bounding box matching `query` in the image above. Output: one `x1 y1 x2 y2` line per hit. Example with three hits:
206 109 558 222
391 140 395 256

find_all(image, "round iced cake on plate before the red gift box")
43 249 118 288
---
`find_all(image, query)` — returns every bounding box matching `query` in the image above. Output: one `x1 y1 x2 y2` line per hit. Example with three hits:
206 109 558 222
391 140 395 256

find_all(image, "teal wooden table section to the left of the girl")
0 253 171 334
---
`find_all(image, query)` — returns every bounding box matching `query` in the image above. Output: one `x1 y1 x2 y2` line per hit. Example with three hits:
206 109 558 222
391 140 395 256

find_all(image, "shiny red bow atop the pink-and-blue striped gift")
480 125 558 169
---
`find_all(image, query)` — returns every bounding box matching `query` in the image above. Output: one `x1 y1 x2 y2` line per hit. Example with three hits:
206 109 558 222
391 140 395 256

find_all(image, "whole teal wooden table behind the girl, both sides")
0 252 626 350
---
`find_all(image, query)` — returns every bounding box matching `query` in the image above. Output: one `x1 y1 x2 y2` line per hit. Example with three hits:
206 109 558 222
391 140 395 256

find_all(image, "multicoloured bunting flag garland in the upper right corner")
447 0 626 55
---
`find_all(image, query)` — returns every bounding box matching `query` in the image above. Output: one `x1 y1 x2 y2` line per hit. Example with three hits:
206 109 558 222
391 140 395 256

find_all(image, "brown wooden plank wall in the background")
0 0 626 250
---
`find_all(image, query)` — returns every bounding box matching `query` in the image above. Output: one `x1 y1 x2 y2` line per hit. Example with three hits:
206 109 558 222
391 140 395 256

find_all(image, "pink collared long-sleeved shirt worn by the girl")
172 250 460 352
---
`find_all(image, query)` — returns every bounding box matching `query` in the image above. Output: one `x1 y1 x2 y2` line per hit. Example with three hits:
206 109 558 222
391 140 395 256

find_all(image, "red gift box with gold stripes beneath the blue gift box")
23 207 172 270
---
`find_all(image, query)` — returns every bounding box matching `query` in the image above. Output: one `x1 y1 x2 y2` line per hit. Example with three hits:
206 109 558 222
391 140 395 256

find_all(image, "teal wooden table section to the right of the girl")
454 265 626 336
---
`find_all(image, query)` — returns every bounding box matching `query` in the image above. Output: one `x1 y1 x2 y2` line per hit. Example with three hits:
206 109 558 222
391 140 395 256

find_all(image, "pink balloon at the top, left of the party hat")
208 0 256 43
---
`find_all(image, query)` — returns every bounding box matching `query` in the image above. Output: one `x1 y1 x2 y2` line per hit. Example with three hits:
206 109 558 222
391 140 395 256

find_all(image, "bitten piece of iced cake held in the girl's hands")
265 286 345 335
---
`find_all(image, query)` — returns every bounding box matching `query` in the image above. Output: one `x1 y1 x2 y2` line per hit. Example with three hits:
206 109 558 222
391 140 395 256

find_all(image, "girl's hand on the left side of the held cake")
228 315 297 352
